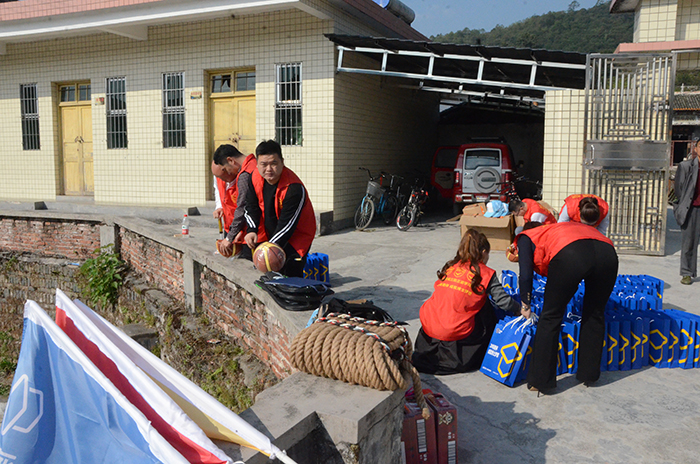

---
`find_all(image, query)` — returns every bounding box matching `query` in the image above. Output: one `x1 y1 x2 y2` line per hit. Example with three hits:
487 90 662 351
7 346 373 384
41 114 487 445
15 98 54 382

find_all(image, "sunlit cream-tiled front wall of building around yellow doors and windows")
0 0 426 220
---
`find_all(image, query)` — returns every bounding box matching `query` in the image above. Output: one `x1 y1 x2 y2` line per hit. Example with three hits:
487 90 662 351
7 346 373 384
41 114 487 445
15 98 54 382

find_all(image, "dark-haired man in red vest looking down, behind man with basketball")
212 145 256 259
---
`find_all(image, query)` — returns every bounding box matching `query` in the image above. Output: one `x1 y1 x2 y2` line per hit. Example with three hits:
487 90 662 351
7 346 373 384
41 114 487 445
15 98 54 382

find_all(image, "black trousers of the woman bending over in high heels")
527 240 618 390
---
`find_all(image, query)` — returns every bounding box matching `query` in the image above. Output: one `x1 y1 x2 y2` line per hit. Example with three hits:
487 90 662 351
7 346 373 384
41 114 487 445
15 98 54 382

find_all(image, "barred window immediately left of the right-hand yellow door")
163 72 185 148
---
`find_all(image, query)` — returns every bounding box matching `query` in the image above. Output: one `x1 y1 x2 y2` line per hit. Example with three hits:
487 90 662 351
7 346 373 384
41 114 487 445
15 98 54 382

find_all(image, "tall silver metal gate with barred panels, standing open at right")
583 54 676 255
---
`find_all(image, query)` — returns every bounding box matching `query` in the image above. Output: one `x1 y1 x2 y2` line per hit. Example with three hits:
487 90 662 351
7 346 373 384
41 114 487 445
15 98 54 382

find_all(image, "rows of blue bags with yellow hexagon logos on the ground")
482 271 700 385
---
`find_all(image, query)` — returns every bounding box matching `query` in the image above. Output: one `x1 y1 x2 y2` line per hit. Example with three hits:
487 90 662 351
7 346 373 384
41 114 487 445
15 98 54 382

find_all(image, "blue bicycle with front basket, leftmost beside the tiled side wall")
355 167 402 230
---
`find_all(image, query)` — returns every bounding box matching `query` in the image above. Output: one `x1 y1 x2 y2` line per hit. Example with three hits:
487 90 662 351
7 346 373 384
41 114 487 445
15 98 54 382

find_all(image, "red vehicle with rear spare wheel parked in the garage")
431 137 515 214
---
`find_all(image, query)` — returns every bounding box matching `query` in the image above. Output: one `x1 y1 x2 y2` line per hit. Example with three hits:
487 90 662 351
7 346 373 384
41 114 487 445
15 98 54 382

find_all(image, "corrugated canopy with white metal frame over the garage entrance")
326 34 586 101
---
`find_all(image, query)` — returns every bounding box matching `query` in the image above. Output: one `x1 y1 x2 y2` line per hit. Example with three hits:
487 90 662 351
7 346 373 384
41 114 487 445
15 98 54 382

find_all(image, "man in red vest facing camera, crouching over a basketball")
245 140 316 277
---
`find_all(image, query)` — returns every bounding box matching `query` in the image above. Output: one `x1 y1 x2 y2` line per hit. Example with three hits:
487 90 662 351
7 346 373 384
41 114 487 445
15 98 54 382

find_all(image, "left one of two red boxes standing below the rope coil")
401 399 438 464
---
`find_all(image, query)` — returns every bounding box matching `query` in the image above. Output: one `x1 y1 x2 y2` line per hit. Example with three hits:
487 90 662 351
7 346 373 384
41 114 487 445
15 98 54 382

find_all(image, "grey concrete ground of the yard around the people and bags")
0 200 700 463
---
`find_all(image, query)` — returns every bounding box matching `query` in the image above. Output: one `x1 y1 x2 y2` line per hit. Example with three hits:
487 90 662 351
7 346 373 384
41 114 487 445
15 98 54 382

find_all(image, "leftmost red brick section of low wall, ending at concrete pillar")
0 217 100 260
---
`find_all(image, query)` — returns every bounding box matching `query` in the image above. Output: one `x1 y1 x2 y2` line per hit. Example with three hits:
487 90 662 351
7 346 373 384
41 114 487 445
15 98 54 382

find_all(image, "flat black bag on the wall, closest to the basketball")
255 272 333 311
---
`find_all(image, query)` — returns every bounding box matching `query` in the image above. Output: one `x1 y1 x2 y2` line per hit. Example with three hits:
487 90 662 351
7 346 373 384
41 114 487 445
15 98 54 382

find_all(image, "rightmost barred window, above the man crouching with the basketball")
275 63 303 145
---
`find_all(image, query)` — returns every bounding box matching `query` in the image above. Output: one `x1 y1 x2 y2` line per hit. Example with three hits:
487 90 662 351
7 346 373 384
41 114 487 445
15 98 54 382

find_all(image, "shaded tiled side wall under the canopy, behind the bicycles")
335 55 439 221
